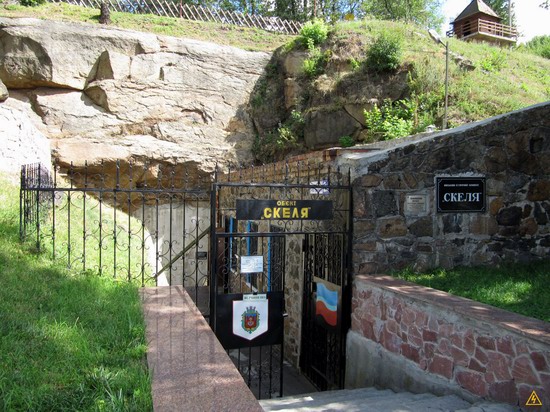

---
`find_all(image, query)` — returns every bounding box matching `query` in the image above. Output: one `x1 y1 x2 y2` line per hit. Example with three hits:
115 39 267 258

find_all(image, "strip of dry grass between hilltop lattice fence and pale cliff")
0 0 294 52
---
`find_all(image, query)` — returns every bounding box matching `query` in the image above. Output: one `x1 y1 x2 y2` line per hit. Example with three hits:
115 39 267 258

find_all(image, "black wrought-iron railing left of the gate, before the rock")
20 162 210 288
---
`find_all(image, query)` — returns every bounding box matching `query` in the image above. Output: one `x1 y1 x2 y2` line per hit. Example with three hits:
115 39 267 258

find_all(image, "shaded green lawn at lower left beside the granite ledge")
0 175 152 411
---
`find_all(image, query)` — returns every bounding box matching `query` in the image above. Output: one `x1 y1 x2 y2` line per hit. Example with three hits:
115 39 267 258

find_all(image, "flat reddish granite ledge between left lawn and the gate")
141 286 262 412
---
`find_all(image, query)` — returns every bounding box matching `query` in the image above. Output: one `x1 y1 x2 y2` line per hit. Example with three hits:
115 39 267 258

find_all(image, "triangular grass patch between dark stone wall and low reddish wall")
394 261 550 322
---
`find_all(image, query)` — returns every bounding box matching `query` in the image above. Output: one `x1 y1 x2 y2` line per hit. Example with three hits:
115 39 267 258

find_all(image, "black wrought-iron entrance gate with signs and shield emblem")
210 165 351 399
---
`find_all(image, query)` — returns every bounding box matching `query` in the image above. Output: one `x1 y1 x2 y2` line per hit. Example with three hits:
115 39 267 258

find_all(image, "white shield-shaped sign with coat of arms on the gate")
233 295 269 340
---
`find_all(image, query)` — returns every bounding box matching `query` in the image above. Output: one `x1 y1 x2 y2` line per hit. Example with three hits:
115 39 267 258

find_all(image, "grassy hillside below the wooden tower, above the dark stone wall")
334 20 550 126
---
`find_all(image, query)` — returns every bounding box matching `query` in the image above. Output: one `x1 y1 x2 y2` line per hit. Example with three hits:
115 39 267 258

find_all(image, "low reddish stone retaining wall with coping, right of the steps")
346 276 550 411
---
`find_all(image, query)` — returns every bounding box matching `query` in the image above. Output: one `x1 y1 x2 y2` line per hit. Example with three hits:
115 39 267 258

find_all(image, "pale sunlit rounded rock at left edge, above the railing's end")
0 105 51 174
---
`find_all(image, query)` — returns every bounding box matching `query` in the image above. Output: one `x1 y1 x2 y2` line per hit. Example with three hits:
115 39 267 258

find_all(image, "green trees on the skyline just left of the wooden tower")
363 0 443 29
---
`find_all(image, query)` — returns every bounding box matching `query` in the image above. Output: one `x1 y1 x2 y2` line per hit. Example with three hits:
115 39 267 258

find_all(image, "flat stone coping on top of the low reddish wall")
355 275 550 345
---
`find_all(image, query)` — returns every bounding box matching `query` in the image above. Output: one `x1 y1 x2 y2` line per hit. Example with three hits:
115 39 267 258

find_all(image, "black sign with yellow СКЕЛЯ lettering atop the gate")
236 199 333 220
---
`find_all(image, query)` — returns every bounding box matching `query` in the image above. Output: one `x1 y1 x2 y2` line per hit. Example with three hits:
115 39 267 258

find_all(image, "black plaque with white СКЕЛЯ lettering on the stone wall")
435 177 486 213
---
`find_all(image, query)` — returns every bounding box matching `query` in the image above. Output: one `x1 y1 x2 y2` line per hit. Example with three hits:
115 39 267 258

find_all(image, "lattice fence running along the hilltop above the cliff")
55 0 303 35
